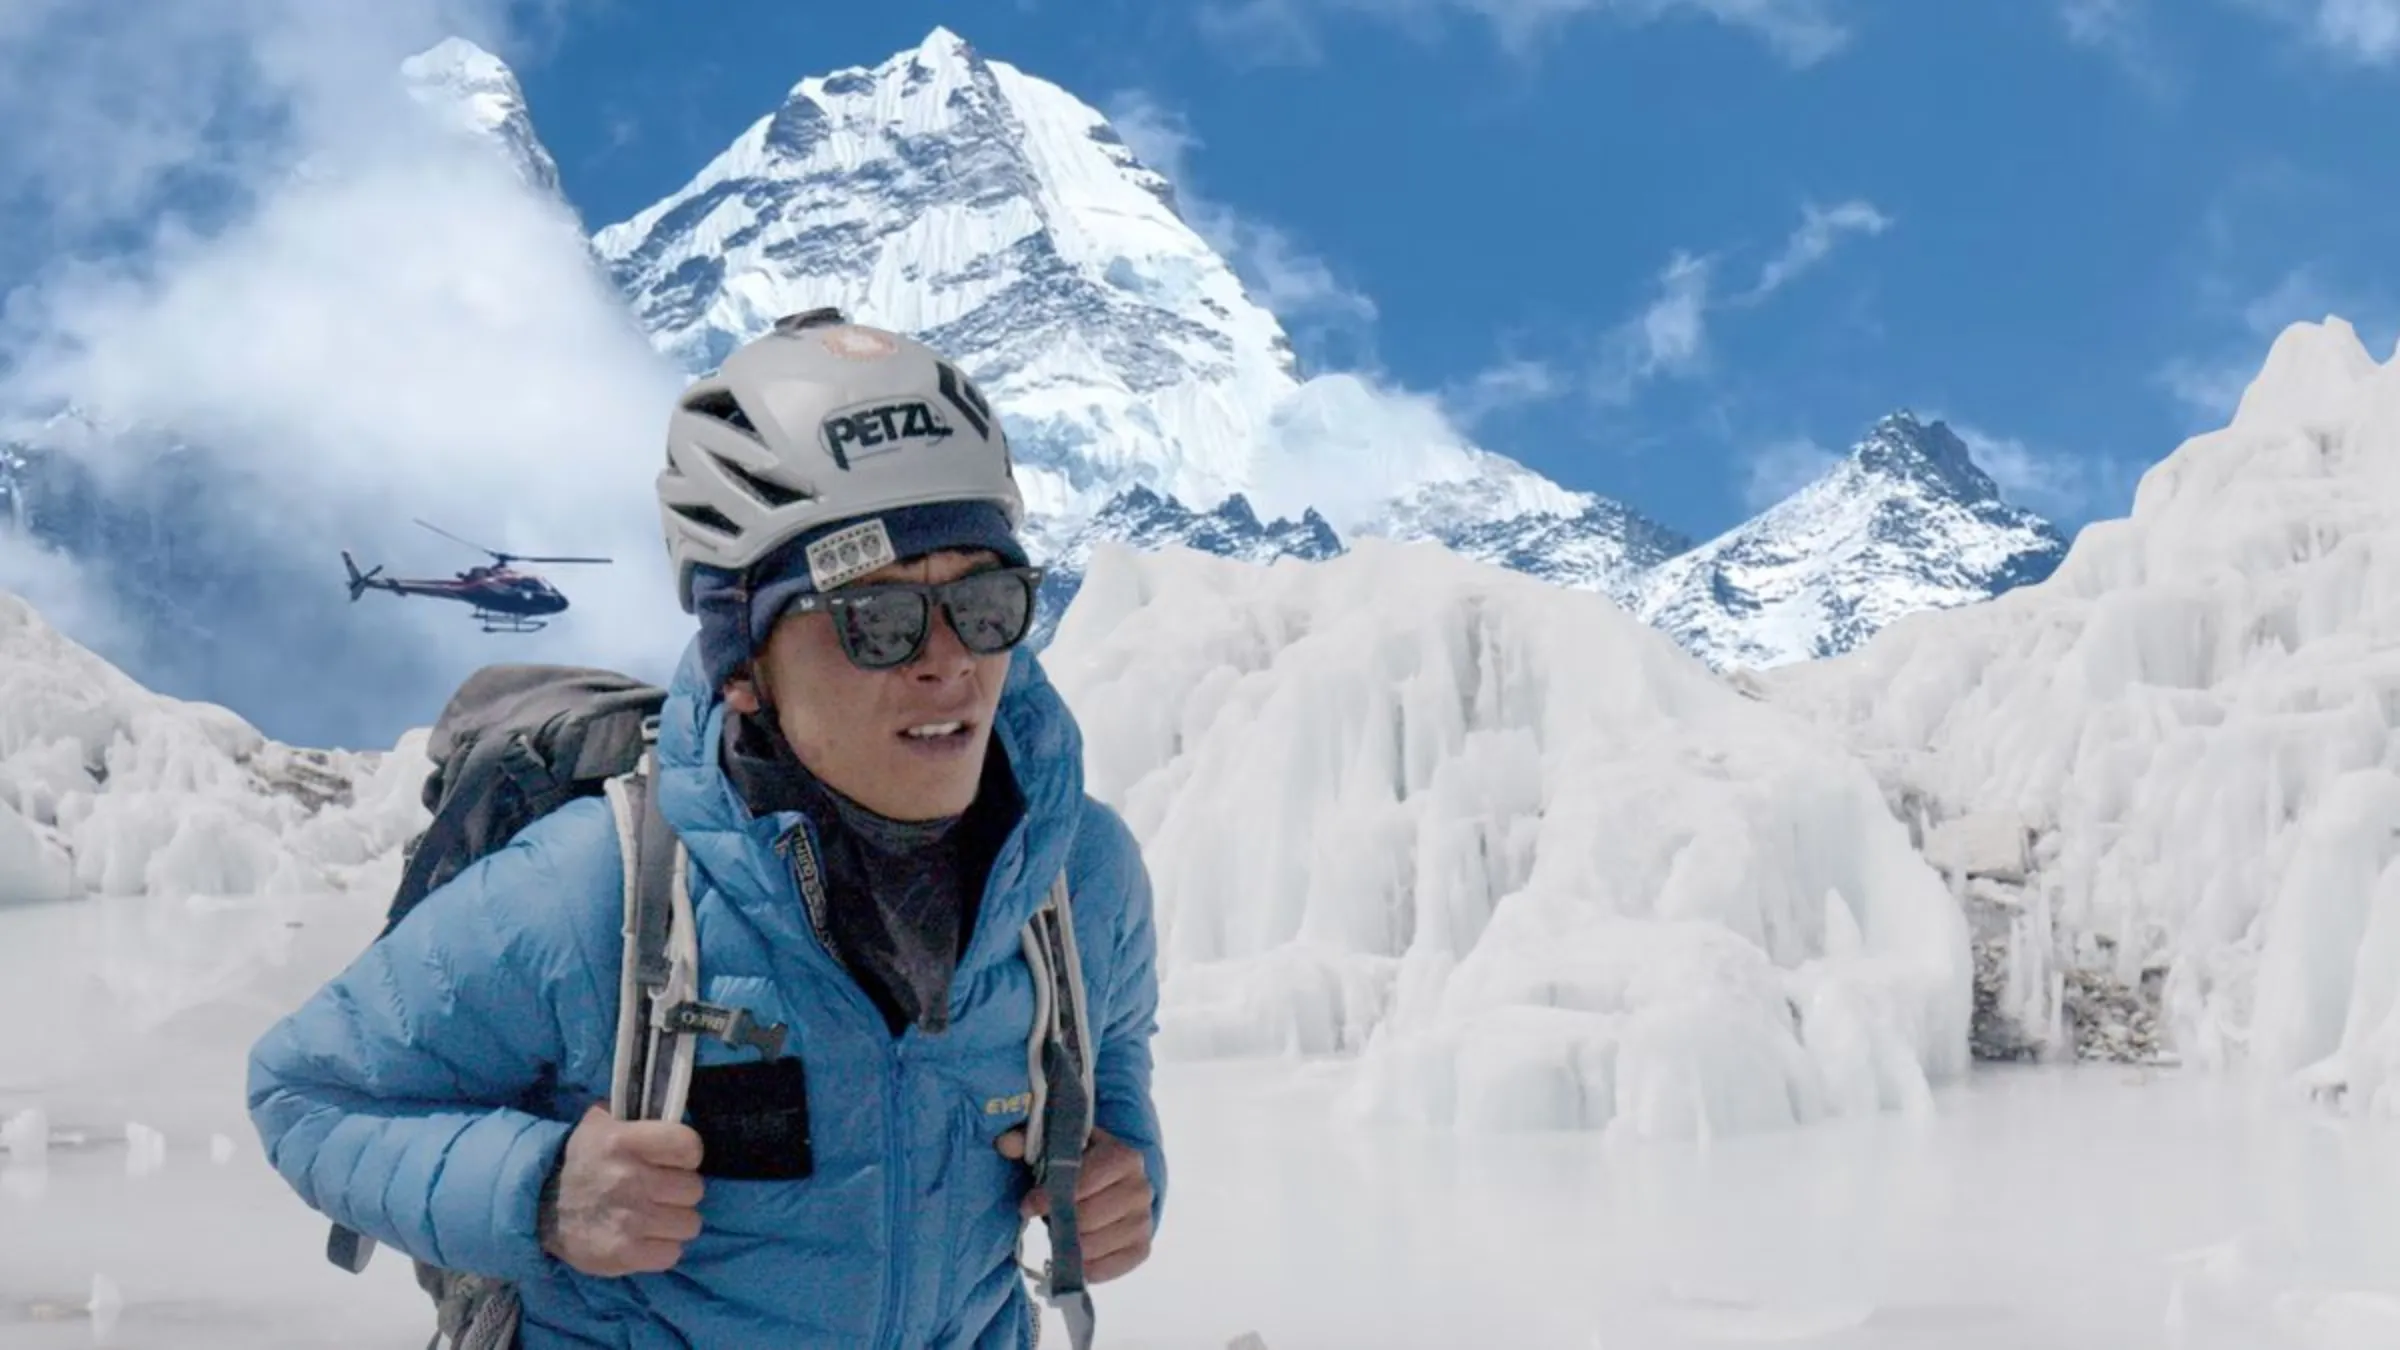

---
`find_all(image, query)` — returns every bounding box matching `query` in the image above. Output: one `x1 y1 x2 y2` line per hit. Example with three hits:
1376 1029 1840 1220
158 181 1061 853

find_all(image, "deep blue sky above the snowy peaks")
509 0 2400 533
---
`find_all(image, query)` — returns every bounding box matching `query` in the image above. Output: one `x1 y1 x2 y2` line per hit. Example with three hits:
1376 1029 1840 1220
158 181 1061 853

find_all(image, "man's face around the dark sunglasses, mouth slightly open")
725 550 1008 819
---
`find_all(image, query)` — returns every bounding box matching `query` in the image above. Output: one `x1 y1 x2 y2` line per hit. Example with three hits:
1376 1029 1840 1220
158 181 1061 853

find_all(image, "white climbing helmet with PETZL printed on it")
658 310 1025 613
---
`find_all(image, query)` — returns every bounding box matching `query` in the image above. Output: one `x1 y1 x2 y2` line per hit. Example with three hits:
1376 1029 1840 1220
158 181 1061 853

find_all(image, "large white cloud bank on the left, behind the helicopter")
0 0 689 711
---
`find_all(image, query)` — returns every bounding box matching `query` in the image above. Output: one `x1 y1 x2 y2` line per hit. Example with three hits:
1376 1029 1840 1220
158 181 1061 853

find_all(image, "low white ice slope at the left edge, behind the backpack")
0 591 430 903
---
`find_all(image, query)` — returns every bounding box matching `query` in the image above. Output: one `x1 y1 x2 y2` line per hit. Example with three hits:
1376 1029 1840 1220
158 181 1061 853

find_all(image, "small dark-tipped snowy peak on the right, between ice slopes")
1639 411 2066 668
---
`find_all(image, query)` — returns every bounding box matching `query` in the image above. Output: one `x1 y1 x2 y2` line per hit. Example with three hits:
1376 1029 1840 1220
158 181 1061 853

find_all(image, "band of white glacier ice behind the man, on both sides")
14 322 2400 1136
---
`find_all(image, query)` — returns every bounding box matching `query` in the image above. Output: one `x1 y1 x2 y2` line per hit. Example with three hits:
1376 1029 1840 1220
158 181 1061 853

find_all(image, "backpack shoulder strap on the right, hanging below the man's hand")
1025 872 1097 1350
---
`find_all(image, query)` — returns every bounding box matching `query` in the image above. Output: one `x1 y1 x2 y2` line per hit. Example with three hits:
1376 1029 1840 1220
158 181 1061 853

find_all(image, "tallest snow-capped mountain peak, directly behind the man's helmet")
595 29 1536 526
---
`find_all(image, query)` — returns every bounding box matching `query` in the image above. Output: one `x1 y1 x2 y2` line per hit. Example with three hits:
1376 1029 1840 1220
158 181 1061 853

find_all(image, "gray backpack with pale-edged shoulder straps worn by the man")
326 665 1097 1350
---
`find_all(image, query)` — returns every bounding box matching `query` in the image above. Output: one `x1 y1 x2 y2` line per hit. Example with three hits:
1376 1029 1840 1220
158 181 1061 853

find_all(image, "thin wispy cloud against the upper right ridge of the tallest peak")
1106 89 1375 334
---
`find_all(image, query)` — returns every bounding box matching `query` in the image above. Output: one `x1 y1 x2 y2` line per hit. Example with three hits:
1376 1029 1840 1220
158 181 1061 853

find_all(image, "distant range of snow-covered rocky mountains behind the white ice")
0 29 2066 744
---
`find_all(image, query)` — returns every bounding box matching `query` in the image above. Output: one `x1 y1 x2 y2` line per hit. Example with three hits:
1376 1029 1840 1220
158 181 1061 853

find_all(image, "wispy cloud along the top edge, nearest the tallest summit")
1200 0 1850 67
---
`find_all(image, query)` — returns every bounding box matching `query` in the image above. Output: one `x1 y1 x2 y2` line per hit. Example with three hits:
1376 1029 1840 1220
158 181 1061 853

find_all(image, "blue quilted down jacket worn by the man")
250 634 1166 1350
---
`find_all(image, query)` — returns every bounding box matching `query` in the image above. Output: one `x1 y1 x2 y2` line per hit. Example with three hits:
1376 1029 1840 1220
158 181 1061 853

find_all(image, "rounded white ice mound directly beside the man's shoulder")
1049 540 1970 1134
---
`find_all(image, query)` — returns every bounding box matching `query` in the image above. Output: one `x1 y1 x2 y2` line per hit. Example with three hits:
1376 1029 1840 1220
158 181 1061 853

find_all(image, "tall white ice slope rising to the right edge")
1759 319 2400 1115
